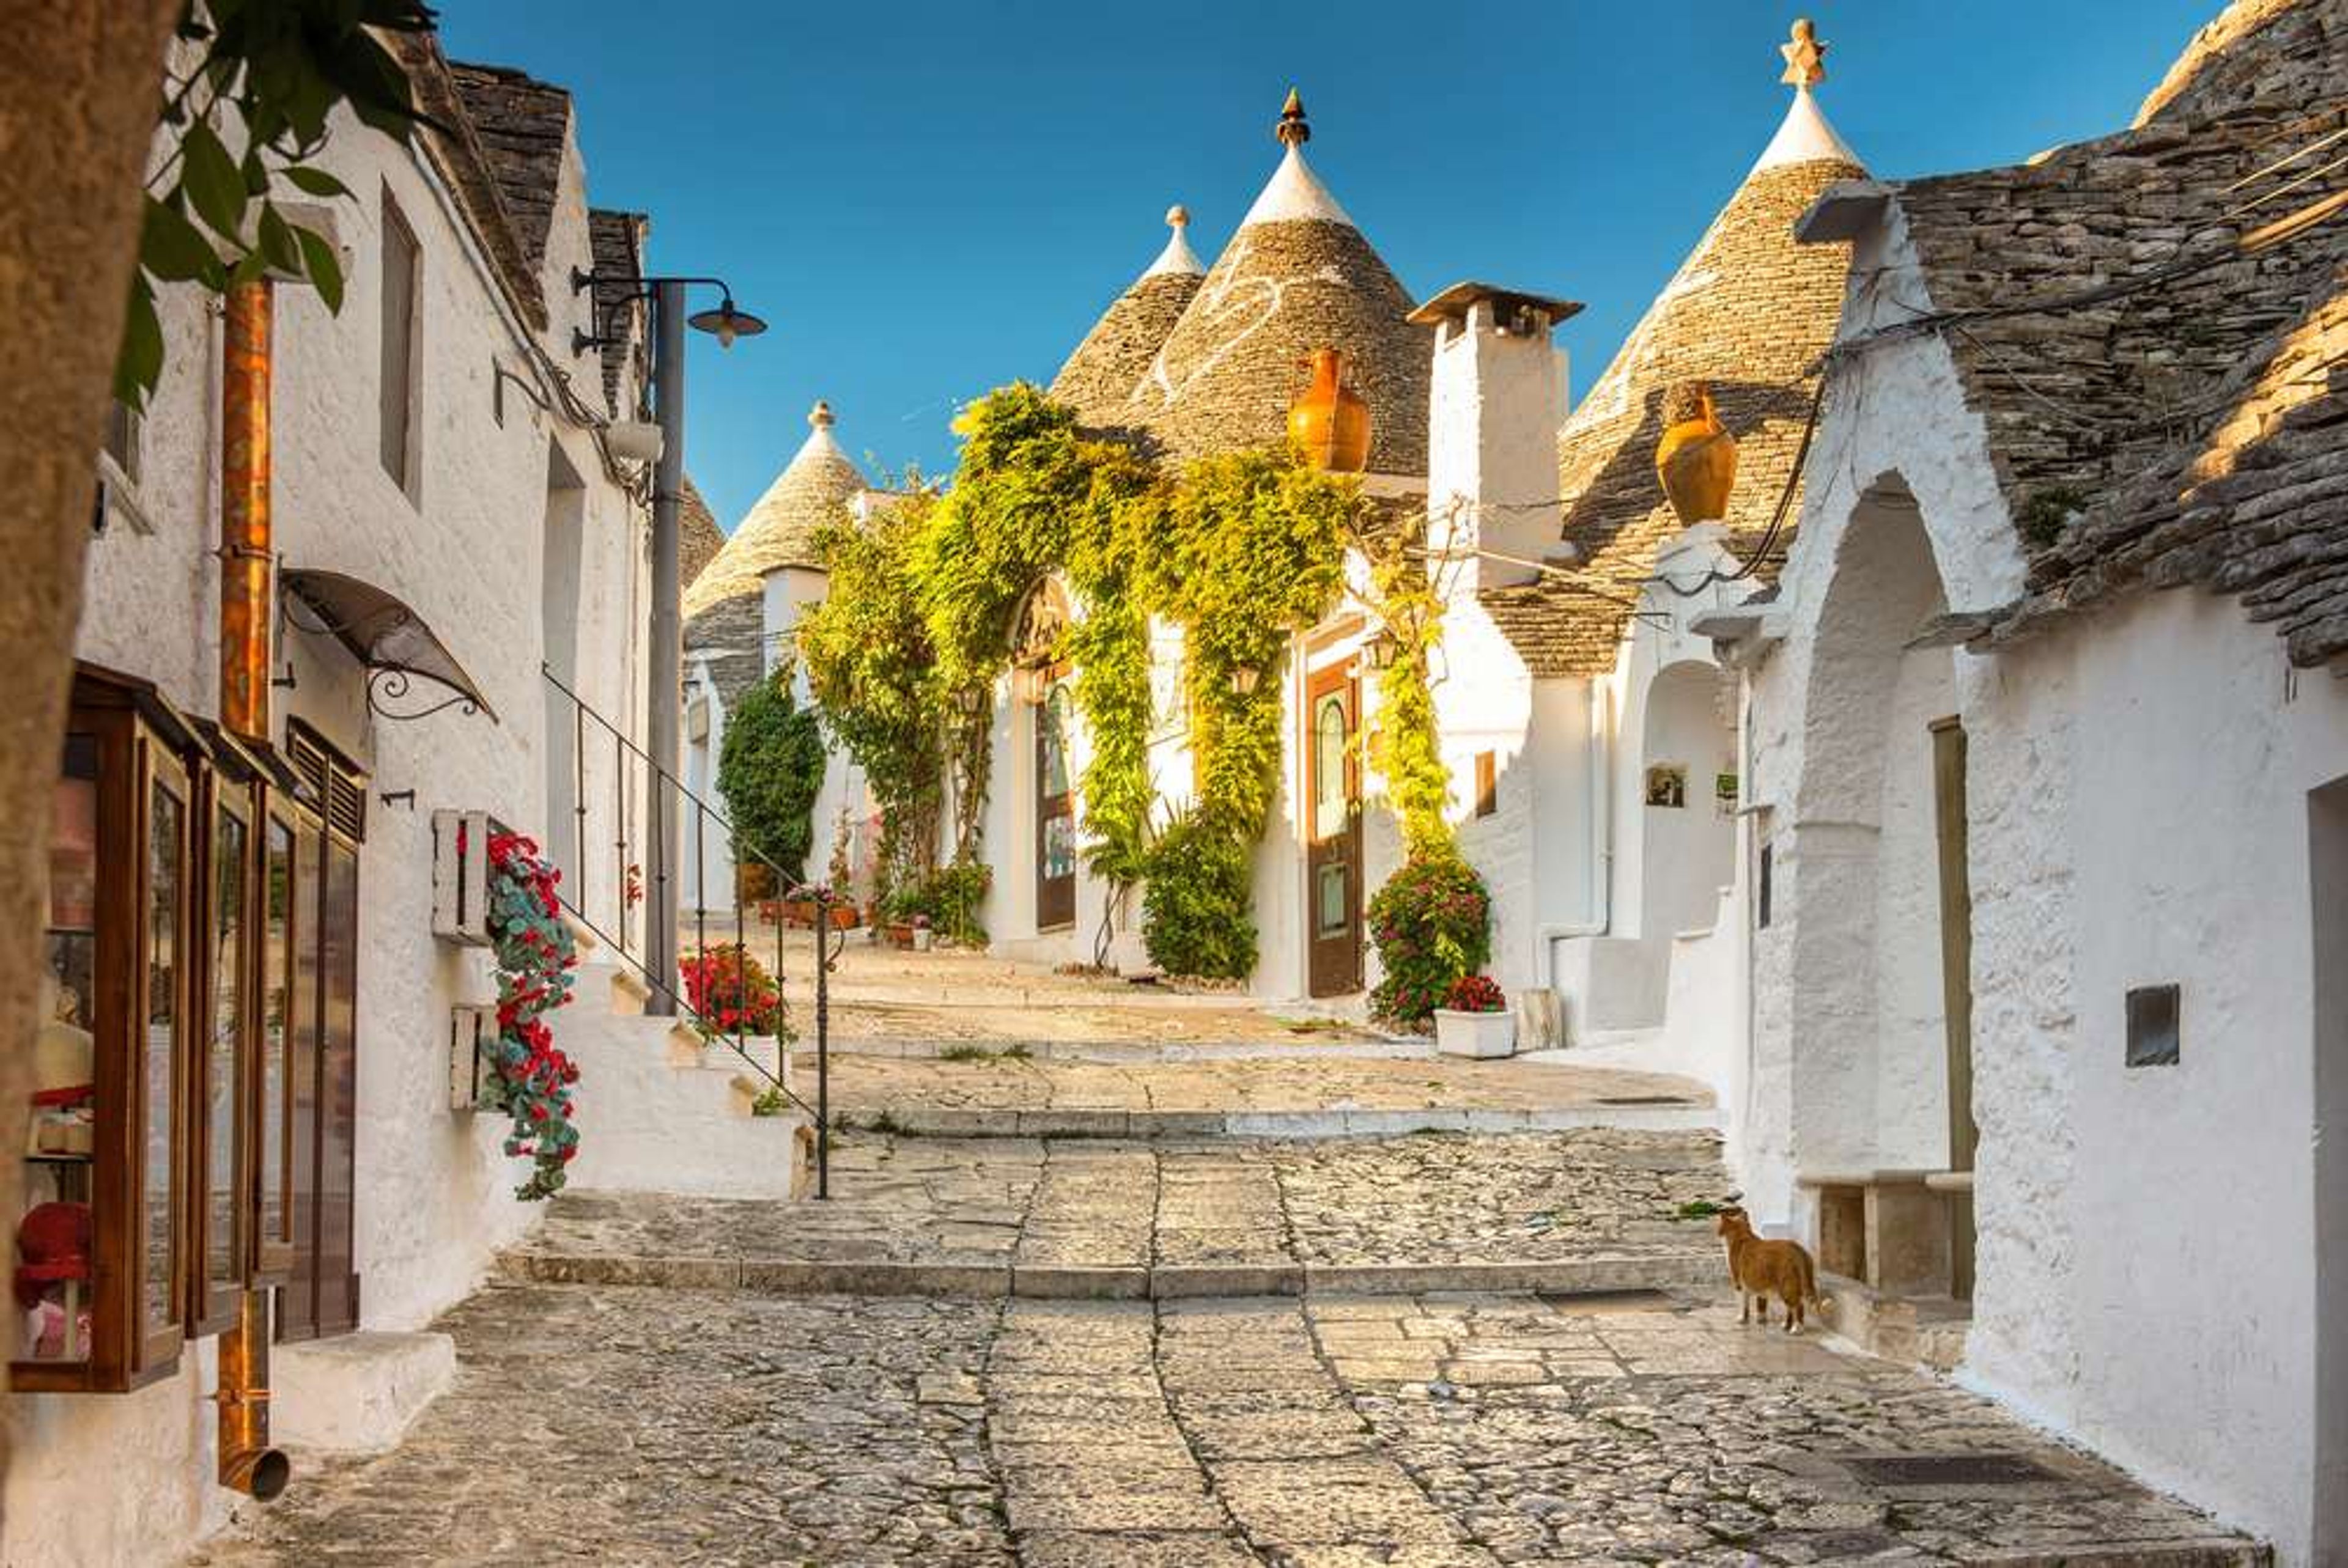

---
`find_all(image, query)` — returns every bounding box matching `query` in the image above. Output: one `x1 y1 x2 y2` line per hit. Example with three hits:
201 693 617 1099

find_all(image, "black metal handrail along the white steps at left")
540 664 838 1197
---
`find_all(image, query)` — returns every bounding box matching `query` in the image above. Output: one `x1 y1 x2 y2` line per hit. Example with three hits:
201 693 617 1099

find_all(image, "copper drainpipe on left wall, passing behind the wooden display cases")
213 277 294 1502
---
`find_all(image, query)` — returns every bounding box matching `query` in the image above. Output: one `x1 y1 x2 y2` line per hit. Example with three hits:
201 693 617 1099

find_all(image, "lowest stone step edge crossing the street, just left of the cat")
498 1246 1721 1300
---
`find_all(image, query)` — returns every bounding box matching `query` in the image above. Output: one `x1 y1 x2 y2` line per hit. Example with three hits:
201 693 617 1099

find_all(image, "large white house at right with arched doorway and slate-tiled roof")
1710 0 2348 1563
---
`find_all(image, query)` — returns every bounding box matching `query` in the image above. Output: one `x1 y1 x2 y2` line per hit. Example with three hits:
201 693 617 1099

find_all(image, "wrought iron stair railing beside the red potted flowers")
540 667 845 1197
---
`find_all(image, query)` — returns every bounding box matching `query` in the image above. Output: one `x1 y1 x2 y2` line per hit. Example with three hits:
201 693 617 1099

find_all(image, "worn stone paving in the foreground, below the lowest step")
195 1286 2264 1568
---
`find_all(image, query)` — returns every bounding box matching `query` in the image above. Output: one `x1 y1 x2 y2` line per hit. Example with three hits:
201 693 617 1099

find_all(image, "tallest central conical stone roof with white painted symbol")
1120 92 1434 474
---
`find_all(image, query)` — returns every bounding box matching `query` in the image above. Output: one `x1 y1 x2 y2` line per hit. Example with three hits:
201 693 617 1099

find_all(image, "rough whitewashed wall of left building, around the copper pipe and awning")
13 101 646 1563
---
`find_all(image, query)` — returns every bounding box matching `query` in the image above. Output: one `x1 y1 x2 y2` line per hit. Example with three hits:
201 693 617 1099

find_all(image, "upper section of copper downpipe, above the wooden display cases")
221 277 275 740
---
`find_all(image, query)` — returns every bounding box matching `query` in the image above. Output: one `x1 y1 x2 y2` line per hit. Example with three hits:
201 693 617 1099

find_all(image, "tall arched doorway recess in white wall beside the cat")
1792 476 1974 1296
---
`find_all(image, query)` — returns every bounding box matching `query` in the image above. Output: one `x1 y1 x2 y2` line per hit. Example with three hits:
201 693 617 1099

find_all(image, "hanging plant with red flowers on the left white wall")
481 833 580 1202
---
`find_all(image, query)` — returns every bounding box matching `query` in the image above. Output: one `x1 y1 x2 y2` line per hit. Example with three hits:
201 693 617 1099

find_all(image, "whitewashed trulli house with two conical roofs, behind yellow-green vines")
981 94 1432 998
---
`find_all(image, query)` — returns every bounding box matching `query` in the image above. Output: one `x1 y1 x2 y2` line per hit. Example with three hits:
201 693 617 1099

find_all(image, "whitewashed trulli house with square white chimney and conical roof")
1390 24 1862 1051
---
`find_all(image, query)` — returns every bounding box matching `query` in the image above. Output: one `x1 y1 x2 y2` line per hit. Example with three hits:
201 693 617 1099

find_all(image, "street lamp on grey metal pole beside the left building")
570 268 766 1017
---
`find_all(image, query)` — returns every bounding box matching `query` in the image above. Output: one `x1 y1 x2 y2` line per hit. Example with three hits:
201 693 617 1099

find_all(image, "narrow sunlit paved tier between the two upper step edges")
794 1047 1716 1138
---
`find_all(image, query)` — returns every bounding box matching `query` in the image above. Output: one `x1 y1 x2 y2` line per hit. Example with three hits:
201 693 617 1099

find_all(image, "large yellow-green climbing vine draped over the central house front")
799 383 1359 976
